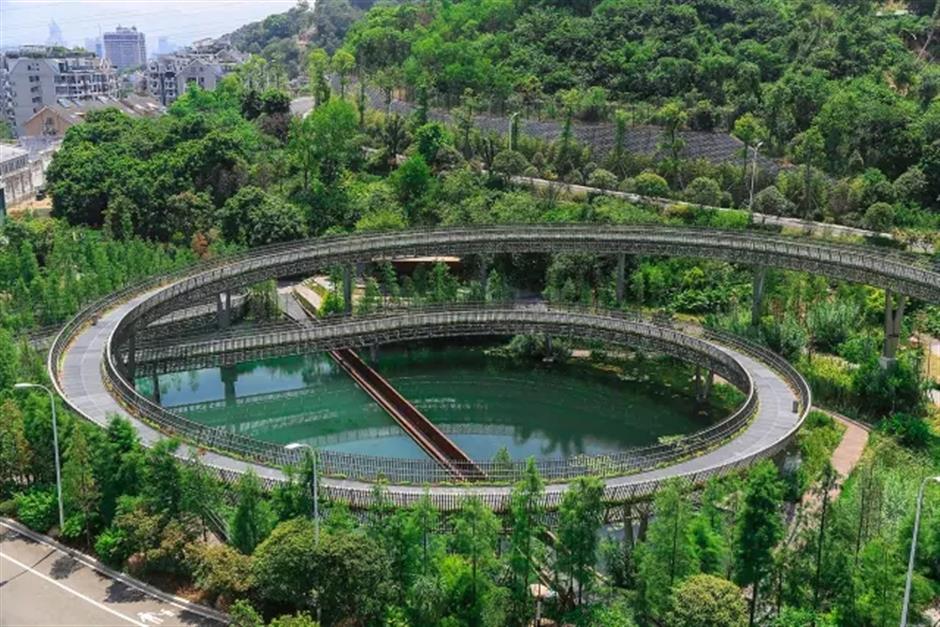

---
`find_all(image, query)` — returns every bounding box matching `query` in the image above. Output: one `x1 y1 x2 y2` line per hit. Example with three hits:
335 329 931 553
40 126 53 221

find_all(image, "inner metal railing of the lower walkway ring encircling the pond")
99 305 772 485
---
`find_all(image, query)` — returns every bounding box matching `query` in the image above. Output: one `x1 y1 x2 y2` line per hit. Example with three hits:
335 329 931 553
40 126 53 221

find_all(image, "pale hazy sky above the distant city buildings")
0 0 298 54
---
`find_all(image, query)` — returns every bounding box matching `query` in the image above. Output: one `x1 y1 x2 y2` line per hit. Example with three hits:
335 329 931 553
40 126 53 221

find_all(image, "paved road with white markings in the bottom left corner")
0 520 225 627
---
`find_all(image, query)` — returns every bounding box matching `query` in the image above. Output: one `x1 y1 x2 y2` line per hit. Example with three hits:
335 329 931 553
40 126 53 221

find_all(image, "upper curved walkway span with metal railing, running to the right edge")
115 224 940 336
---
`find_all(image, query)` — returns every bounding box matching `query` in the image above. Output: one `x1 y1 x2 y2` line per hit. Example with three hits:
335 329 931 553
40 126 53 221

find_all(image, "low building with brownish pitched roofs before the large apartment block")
22 94 166 138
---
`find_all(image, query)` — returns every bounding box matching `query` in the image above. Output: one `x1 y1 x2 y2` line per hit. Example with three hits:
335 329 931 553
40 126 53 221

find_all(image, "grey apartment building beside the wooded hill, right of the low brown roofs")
147 39 247 105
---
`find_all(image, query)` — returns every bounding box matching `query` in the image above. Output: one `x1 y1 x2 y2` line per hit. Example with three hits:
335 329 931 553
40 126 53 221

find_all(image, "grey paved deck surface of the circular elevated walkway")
57 290 808 510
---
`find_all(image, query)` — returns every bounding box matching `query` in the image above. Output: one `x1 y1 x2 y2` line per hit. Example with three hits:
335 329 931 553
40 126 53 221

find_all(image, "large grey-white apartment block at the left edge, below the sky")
0 50 118 134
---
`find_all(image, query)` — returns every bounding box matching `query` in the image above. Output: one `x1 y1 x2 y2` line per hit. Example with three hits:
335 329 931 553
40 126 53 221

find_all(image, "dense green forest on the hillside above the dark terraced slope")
332 0 940 230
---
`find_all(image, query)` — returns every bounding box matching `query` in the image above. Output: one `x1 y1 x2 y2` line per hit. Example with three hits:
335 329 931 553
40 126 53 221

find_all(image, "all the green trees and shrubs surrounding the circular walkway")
0 0 940 627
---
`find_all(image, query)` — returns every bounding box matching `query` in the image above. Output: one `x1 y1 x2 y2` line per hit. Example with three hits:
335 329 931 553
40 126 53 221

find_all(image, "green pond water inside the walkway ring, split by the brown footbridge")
138 344 721 460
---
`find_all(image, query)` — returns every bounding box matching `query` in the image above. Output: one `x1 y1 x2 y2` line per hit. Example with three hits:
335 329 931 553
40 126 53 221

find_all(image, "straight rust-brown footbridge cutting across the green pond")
285 290 485 480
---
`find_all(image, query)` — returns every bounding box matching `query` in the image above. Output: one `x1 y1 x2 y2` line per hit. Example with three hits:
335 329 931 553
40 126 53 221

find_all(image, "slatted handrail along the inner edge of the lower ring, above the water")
99 305 776 484
